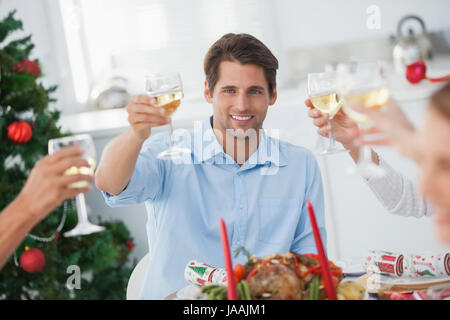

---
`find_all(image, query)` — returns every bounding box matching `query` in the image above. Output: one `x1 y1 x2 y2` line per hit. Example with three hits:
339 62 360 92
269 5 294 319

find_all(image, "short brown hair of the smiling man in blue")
204 33 278 97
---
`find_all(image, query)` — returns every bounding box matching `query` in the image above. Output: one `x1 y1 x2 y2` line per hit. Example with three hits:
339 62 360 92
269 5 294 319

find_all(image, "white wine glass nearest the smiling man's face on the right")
308 72 346 155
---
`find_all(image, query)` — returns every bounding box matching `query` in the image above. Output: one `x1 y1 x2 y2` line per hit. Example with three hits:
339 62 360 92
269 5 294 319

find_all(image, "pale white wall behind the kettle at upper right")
275 0 450 50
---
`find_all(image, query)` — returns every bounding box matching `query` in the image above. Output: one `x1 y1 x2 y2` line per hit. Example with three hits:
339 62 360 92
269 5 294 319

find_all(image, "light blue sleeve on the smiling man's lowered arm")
291 153 327 254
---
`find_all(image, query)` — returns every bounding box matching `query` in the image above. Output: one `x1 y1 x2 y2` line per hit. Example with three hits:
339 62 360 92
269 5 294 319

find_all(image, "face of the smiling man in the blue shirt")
204 61 277 138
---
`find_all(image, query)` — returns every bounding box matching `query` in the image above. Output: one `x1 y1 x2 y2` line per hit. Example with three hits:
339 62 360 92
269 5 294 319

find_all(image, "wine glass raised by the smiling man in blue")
145 71 191 161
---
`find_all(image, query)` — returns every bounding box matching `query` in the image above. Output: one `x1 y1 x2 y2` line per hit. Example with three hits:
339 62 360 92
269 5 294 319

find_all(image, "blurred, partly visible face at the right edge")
420 108 450 243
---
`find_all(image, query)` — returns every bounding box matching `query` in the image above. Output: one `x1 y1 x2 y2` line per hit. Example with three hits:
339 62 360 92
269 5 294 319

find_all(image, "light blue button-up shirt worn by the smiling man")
103 120 326 299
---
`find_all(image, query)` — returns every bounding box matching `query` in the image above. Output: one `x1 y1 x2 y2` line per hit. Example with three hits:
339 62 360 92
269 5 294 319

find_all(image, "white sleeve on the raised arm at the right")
364 157 432 218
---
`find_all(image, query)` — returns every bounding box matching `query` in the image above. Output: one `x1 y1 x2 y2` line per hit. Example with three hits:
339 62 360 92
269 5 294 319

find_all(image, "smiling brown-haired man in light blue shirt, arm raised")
96 34 326 299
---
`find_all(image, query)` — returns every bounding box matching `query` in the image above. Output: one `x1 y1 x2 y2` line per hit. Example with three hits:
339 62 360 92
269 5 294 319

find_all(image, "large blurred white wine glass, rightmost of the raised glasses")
337 61 391 177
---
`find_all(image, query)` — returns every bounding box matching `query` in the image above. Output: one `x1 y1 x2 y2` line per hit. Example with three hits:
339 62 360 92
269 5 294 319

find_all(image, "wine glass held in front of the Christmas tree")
48 134 105 237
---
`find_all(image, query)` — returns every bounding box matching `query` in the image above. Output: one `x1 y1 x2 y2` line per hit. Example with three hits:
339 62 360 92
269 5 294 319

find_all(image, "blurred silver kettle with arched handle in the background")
393 15 433 74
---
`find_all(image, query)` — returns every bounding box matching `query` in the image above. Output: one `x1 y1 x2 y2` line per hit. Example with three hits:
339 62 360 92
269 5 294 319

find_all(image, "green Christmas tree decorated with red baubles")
0 11 136 299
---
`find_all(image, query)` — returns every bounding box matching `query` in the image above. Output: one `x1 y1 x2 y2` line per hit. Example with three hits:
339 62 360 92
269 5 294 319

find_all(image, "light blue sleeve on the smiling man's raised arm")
102 135 167 208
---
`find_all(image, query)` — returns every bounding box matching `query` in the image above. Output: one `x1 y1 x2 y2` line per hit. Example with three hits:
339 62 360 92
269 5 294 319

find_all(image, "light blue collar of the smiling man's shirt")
192 116 287 167
